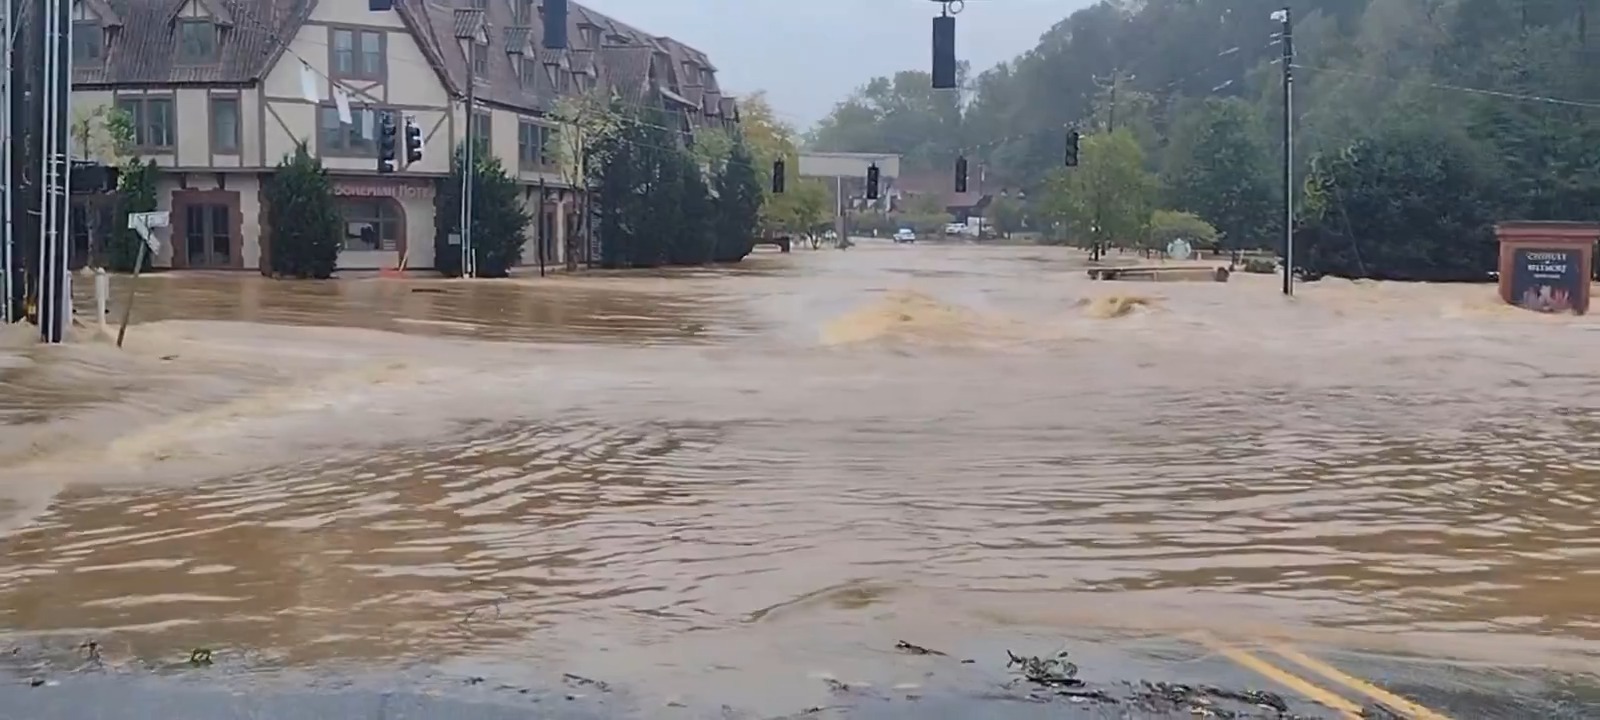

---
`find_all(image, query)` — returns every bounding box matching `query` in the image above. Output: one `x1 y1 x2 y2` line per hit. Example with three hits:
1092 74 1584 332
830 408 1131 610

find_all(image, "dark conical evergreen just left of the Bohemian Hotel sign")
266 142 344 280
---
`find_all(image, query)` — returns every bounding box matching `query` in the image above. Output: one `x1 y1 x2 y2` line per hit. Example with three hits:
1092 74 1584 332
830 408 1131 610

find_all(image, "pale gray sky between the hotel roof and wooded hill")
579 0 1093 130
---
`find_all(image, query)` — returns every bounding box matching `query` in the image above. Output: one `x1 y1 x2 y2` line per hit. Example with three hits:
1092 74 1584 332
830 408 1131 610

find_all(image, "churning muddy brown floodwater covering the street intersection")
0 243 1600 704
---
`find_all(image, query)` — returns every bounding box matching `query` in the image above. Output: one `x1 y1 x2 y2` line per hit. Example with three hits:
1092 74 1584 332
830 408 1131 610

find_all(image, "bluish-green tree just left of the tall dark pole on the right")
1162 99 1282 250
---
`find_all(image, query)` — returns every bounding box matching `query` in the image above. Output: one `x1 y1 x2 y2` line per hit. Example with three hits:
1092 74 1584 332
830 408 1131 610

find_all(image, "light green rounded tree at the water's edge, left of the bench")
1040 130 1154 258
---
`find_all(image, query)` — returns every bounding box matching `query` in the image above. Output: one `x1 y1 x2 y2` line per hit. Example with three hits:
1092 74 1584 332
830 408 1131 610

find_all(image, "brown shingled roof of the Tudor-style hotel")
72 0 736 124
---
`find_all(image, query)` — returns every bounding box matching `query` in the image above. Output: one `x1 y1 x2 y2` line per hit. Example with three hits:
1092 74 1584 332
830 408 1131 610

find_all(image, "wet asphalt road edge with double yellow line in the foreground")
0 638 1600 720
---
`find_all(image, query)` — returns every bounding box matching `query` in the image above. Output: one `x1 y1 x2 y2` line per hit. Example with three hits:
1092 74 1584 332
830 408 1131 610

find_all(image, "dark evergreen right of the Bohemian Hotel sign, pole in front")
434 142 533 277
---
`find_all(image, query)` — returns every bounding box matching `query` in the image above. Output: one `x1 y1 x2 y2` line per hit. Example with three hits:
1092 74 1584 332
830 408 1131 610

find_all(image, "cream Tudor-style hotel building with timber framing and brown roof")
72 0 739 270
